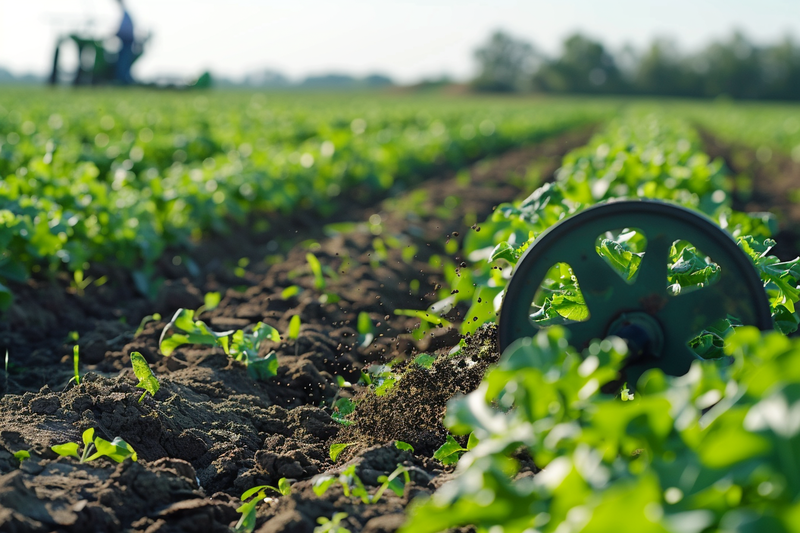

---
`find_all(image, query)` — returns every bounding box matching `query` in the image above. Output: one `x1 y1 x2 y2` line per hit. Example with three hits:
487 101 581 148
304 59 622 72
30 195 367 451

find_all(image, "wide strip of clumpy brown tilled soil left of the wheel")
0 131 589 533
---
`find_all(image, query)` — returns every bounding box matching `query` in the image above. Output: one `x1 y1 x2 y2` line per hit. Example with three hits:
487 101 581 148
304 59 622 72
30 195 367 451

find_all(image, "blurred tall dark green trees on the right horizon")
472 31 800 100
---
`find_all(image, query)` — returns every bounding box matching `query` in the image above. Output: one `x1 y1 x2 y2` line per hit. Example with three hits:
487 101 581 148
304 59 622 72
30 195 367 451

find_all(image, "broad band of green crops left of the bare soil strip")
0 92 611 305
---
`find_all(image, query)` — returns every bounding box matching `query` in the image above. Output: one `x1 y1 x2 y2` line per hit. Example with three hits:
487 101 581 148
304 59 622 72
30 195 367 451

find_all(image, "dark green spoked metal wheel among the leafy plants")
498 200 772 384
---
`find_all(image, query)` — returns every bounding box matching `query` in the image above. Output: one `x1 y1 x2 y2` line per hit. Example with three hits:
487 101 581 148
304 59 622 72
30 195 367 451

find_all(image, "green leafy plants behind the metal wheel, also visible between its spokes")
454 109 800 358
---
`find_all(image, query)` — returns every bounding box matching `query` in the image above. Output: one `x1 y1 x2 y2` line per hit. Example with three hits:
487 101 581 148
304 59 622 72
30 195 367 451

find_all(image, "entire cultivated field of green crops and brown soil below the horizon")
0 89 800 533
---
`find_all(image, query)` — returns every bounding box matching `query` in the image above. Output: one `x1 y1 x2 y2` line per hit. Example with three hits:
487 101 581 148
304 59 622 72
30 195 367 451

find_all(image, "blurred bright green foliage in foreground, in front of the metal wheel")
403 327 800 533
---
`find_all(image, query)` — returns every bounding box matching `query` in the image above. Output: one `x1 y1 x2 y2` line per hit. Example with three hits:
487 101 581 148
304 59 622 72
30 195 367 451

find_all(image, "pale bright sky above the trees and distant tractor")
0 0 800 83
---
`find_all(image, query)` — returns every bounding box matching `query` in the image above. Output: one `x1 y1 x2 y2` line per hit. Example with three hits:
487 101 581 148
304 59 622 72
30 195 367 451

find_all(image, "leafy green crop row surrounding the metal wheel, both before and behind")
403 116 800 533
